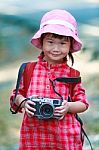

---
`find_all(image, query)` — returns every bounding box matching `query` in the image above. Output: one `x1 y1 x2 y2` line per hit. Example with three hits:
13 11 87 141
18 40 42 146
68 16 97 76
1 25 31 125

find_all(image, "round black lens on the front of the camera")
40 103 54 119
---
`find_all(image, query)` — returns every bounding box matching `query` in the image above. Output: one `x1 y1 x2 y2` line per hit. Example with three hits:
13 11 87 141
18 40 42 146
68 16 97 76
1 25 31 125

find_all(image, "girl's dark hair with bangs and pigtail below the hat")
40 33 74 66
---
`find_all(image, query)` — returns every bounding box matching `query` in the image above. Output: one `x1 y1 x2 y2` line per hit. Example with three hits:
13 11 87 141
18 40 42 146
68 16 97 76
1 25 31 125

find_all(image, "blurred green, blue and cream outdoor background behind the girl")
0 0 99 150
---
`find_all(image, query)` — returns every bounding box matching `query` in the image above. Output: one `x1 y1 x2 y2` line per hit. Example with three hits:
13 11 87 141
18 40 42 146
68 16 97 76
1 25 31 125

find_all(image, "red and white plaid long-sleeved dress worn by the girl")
10 57 88 150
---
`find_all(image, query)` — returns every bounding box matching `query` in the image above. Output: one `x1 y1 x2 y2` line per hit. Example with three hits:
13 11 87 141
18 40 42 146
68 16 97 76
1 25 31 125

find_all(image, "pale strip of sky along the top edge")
0 0 99 15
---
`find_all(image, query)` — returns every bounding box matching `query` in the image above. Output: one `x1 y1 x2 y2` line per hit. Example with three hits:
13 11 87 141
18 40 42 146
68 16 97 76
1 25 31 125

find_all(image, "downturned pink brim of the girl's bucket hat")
31 25 82 53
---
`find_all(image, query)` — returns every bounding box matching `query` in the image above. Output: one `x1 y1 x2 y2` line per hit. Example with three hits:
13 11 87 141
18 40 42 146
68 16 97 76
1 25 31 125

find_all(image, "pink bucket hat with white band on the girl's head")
31 9 82 53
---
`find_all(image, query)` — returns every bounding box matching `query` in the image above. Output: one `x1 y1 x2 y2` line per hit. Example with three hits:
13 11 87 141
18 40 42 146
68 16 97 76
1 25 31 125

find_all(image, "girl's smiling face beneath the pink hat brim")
42 33 70 64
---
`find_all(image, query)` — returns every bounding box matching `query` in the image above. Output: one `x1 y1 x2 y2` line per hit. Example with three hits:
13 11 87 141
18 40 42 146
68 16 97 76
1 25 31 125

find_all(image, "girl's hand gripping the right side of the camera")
54 100 69 120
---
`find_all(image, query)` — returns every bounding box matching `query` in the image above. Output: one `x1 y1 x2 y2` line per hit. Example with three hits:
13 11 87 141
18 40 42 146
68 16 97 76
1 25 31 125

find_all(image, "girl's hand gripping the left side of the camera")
24 100 36 117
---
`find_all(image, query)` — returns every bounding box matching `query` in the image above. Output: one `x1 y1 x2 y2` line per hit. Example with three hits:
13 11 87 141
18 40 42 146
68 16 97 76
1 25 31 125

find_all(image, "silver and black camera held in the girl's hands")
30 96 62 119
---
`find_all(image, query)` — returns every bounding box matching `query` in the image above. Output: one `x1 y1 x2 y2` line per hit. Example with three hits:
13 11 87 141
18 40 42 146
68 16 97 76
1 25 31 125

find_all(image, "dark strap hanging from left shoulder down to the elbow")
10 63 27 114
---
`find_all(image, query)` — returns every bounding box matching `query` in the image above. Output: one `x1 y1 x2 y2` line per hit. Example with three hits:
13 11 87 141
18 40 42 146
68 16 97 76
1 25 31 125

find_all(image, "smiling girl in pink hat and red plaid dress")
10 9 88 150
